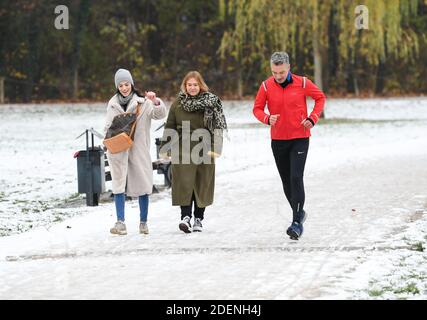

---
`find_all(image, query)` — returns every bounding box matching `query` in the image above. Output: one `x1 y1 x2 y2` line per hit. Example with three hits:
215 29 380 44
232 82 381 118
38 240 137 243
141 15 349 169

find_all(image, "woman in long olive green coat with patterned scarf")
162 71 227 233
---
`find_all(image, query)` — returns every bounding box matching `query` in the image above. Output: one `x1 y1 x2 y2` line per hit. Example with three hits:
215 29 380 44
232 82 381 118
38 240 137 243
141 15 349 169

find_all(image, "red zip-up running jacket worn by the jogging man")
253 73 326 140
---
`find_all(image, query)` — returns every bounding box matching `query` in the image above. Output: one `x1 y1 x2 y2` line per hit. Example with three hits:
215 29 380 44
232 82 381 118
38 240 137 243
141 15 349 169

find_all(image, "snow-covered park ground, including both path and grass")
0 98 427 299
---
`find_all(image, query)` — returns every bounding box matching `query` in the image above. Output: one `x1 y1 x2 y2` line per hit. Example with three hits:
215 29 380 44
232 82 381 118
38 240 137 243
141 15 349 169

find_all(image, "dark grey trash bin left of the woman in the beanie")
74 130 105 206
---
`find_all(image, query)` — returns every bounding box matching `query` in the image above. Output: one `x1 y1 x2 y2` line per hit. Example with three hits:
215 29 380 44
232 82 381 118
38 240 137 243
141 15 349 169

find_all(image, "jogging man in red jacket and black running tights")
253 52 326 240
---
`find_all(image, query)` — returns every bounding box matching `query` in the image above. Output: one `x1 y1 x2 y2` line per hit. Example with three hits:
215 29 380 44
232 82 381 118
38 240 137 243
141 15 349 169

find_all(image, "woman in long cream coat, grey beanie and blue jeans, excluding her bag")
104 69 166 235
